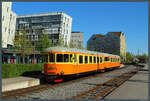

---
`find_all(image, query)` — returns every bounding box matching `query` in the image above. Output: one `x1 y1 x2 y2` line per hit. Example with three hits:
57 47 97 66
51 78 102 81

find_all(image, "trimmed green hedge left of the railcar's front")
2 64 44 78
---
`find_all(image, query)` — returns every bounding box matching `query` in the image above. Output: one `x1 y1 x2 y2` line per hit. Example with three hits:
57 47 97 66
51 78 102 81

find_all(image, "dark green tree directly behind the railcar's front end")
36 33 52 52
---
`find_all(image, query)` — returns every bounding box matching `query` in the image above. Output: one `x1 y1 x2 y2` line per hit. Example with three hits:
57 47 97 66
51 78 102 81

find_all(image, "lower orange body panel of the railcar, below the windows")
44 62 120 75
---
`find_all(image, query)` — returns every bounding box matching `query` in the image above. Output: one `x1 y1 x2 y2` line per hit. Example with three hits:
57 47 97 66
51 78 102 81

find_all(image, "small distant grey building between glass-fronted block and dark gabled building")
70 31 83 48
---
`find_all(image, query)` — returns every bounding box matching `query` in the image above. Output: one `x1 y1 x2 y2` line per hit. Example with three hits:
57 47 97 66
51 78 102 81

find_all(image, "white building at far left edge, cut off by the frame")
2 2 16 48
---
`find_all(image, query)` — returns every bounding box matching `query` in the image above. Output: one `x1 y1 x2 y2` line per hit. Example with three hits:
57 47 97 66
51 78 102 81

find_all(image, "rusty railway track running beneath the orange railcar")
2 65 132 99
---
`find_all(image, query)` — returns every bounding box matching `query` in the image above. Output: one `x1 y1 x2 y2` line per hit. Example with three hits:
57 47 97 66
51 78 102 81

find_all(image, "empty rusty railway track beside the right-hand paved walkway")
72 67 140 100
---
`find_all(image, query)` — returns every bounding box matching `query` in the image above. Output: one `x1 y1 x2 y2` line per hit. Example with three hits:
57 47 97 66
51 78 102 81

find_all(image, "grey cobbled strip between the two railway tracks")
16 65 136 99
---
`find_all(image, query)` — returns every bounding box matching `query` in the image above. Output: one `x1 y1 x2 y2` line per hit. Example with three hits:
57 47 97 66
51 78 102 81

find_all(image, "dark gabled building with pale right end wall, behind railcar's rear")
87 32 126 60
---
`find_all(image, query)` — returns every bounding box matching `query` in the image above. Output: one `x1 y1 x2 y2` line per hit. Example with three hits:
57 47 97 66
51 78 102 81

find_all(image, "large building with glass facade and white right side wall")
16 12 72 45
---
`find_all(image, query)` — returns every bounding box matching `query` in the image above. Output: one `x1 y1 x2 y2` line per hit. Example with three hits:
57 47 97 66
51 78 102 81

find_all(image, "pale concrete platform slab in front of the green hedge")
2 76 40 92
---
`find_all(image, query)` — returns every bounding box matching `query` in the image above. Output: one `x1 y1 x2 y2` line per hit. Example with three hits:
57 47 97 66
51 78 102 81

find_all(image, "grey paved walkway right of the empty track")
105 65 148 99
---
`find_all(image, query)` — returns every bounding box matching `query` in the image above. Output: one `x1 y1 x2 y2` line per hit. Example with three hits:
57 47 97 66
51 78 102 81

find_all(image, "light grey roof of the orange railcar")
45 46 119 57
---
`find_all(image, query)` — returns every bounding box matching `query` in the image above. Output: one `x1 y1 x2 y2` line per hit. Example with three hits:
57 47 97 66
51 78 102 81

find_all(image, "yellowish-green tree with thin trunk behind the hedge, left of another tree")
13 30 34 64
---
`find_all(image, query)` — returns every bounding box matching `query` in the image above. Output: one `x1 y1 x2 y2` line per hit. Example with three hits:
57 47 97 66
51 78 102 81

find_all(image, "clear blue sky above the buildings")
12 2 148 54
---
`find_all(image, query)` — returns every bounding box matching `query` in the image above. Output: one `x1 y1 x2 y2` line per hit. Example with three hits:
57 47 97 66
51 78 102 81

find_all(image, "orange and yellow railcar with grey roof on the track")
44 47 120 81
